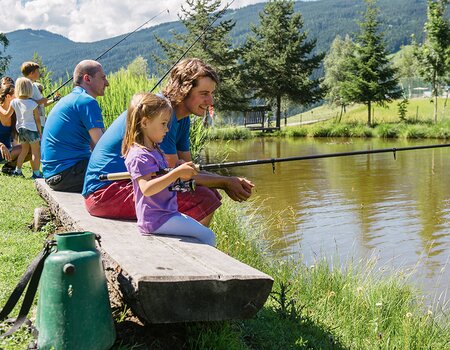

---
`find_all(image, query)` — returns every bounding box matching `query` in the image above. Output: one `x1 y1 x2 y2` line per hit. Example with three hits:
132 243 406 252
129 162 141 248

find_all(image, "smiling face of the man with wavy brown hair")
182 77 216 116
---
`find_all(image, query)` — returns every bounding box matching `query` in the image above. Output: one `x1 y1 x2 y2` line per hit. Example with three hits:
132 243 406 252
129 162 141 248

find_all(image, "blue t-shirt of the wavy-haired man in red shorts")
82 111 190 197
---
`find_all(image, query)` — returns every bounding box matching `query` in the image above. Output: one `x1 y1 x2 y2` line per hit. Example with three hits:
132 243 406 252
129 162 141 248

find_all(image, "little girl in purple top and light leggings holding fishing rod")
122 93 215 246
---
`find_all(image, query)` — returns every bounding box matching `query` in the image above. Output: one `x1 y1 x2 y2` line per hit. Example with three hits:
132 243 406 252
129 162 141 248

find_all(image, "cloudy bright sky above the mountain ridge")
0 0 265 42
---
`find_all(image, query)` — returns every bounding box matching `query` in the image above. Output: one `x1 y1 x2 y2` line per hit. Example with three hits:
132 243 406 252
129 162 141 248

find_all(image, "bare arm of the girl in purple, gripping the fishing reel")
138 162 197 196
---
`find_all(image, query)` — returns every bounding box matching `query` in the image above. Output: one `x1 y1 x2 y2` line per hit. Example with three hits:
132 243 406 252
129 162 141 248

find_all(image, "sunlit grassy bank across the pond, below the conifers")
208 98 450 140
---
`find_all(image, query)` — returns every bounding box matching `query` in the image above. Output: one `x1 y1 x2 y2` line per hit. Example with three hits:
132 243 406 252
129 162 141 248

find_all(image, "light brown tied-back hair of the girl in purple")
122 92 172 156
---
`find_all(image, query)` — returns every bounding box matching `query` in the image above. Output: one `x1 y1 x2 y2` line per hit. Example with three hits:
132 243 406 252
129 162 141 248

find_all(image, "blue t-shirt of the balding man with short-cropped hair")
41 86 104 178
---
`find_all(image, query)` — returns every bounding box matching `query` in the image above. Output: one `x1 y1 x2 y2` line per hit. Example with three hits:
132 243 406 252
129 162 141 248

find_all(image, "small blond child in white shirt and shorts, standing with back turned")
0 78 42 179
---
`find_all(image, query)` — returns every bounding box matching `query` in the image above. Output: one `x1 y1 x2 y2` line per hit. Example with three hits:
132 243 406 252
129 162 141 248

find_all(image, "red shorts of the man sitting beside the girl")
84 180 222 221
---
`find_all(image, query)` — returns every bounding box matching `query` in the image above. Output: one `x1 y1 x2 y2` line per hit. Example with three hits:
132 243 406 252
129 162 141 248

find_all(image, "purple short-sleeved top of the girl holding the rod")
125 145 180 233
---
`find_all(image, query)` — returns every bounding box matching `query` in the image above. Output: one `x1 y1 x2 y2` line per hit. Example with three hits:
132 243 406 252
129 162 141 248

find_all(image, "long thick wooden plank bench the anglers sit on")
36 180 273 323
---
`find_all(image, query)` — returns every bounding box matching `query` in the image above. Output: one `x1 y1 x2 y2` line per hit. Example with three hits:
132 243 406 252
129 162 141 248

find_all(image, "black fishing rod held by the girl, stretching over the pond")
99 143 450 181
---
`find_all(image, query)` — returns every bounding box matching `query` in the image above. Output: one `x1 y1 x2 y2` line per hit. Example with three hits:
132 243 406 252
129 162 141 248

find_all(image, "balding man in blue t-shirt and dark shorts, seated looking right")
41 60 109 193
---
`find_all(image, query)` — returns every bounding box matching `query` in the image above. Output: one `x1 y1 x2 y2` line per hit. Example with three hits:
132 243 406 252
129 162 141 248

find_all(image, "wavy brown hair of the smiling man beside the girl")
163 58 219 106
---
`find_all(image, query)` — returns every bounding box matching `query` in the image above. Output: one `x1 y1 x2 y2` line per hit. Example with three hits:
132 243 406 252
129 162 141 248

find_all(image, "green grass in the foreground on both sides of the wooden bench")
0 176 450 350
